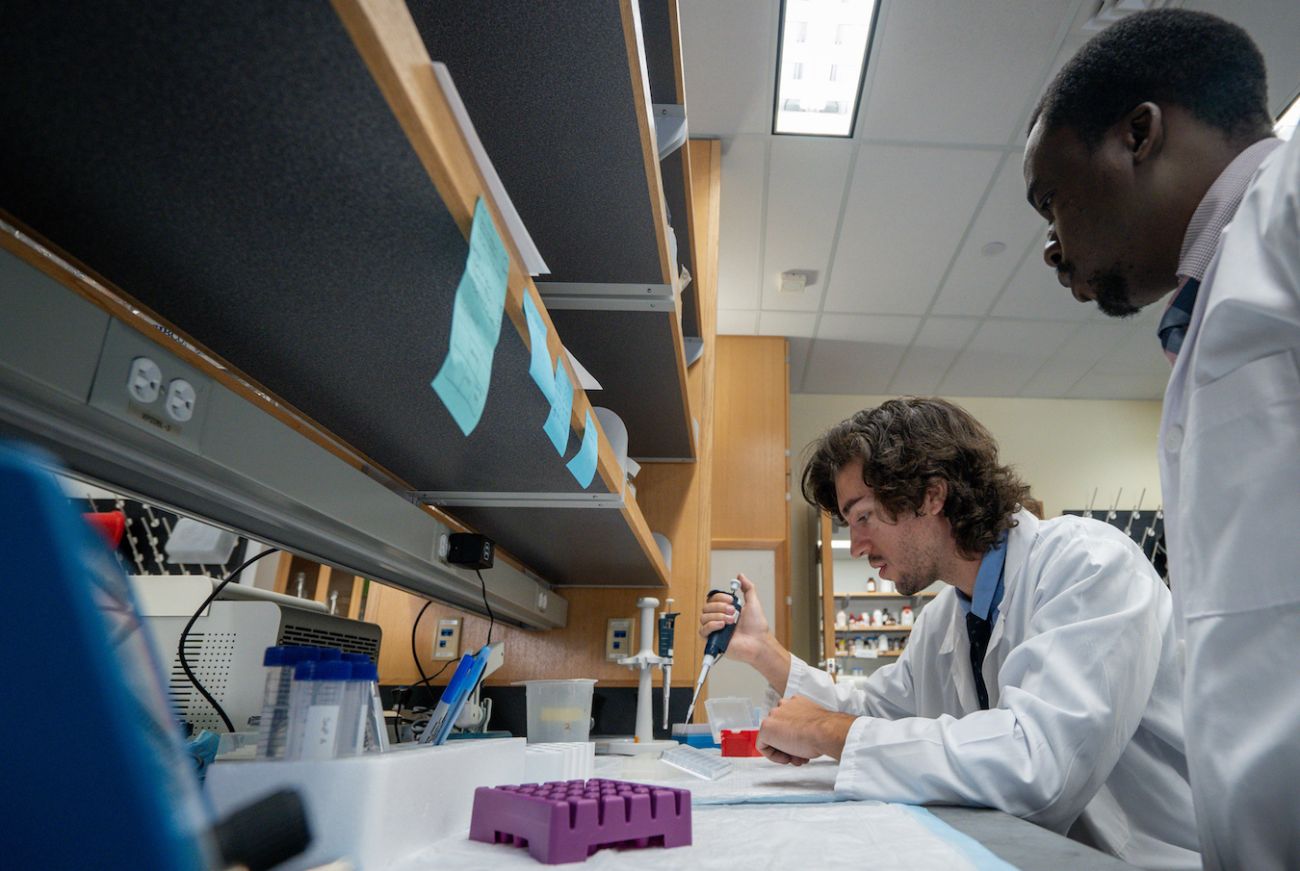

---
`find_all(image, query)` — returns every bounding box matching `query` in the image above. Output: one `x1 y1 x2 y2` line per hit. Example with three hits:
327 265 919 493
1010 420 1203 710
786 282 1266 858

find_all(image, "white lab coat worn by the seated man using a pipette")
787 511 1200 868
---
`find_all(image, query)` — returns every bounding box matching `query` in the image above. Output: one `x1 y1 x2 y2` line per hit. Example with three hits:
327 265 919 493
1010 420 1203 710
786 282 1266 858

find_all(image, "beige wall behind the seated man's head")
790 394 1161 655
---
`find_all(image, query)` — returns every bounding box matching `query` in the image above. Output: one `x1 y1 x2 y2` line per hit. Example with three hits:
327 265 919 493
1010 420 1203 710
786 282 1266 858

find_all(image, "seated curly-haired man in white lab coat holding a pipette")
701 399 1200 868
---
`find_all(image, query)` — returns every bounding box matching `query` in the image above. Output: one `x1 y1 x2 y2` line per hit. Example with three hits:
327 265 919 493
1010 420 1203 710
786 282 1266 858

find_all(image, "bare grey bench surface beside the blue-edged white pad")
930 807 1135 871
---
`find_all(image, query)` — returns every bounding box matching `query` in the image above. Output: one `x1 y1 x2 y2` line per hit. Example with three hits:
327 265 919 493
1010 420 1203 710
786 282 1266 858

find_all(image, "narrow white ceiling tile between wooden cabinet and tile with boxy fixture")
718 137 767 309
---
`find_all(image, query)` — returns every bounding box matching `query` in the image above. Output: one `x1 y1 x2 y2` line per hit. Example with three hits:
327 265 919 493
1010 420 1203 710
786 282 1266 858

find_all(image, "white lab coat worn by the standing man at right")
1160 137 1300 871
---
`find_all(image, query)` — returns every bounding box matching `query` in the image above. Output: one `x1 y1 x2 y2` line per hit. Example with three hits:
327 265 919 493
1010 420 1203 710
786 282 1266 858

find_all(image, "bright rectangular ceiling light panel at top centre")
772 0 876 137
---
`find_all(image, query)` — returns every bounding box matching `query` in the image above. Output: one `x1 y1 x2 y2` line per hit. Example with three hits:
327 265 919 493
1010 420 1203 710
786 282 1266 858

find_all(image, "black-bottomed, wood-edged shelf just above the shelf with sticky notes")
408 0 697 459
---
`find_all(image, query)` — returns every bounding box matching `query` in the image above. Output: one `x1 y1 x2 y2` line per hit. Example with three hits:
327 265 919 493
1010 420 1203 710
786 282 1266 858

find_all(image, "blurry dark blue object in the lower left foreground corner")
0 443 216 871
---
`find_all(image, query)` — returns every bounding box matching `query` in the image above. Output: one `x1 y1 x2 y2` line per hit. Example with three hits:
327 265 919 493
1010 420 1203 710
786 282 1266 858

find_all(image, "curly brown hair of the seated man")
803 397 1030 558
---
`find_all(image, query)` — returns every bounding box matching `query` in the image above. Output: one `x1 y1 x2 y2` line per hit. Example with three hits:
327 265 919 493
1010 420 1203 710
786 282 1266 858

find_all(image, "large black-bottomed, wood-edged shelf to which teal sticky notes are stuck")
0 0 665 586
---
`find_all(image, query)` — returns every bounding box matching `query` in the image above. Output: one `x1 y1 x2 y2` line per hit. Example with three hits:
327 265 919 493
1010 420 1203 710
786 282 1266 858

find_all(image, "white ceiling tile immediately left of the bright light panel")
679 0 780 137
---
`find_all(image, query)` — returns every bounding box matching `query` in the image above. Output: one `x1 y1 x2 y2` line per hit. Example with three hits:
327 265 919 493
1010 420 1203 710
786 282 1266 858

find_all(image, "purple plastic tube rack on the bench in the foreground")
469 779 690 865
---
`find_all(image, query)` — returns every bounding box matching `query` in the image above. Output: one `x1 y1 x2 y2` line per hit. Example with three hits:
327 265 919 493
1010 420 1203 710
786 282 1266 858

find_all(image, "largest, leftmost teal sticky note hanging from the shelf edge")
429 199 510 436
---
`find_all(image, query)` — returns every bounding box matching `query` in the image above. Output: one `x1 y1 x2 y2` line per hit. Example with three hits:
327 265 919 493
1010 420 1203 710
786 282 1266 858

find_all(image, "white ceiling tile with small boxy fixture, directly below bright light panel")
761 138 854 312
